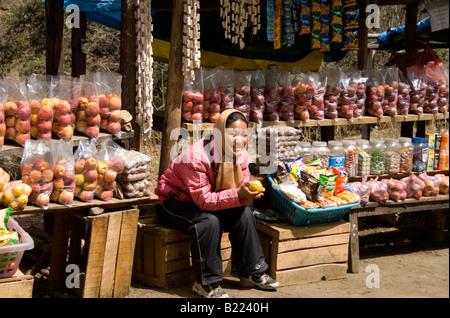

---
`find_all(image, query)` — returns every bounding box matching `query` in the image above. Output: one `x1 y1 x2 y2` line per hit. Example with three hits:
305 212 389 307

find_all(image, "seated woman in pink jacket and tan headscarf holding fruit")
155 109 278 298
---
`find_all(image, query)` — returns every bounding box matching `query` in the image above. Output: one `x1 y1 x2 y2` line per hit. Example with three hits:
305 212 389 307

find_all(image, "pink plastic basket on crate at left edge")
0 217 34 278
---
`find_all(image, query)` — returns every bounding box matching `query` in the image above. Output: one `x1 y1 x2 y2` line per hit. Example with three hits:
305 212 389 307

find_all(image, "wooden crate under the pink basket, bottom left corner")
0 269 34 298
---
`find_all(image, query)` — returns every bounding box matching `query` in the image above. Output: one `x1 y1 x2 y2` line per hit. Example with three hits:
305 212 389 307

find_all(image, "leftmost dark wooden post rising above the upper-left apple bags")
45 0 64 75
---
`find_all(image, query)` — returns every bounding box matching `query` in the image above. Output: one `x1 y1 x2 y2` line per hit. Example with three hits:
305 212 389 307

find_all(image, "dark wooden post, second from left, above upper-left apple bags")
72 11 86 77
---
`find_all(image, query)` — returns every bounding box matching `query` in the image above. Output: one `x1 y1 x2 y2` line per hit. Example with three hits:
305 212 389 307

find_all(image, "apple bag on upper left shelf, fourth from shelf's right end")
27 74 53 139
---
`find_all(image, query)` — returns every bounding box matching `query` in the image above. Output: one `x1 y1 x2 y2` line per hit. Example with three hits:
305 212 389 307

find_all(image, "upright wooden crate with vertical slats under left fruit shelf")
49 208 139 298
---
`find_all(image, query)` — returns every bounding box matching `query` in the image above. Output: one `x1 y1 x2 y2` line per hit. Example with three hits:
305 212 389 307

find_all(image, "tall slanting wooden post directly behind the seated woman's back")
159 0 184 176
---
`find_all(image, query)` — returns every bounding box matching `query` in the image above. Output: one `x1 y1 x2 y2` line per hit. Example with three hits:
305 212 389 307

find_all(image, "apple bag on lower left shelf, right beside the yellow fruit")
20 139 53 210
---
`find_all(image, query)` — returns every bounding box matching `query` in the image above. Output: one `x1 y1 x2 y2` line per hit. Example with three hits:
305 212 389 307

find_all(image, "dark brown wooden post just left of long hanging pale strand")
120 0 141 151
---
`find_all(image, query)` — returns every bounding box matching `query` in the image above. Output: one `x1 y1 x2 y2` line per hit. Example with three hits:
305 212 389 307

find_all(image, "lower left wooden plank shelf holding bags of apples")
12 194 158 215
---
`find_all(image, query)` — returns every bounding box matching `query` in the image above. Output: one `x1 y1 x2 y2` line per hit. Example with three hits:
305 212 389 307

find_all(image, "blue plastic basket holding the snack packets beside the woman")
267 175 360 225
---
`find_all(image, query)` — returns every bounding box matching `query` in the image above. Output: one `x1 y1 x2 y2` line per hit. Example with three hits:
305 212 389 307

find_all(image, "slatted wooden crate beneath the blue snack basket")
257 220 350 286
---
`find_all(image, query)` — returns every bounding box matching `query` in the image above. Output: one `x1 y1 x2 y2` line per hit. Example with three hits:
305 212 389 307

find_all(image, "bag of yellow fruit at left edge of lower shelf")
0 180 31 211
